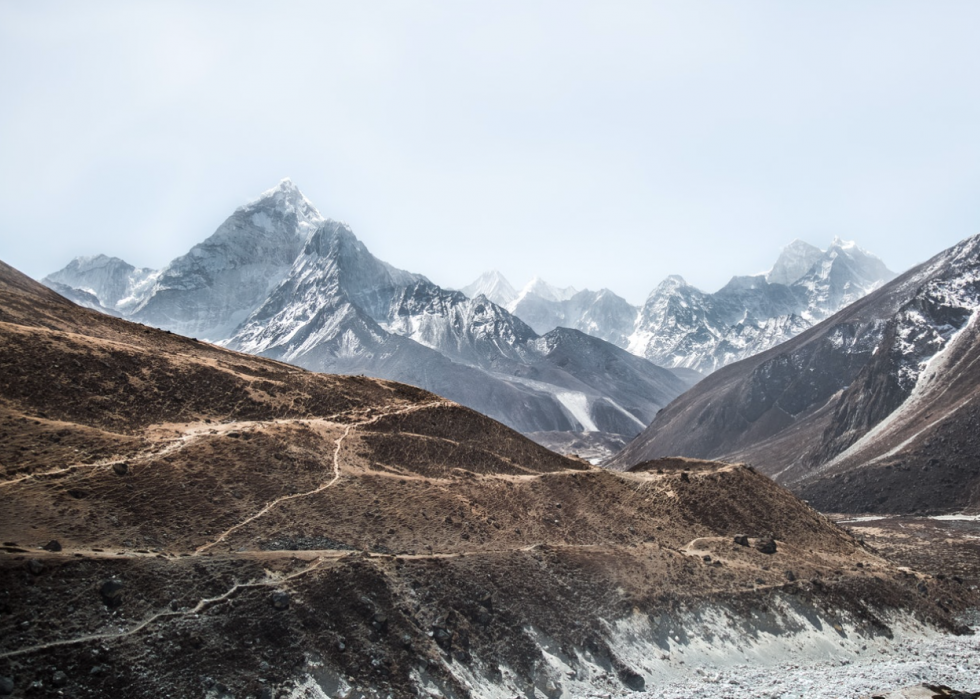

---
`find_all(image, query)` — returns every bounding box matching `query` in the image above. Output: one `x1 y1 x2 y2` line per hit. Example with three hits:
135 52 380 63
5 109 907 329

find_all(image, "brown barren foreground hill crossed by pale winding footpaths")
0 263 968 698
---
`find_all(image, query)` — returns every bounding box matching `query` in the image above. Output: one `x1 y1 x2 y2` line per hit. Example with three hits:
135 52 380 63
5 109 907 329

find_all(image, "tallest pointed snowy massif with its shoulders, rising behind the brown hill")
45 180 690 454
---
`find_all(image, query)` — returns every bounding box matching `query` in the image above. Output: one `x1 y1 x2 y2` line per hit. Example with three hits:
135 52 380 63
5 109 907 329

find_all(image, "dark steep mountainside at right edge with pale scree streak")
611 237 980 512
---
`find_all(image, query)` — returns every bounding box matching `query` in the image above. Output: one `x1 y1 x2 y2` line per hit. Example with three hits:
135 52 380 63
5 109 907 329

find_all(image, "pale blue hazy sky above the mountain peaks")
0 0 980 302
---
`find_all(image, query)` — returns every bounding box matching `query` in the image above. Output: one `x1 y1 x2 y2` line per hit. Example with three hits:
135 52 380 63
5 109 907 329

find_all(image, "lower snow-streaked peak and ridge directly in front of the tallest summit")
215 202 687 434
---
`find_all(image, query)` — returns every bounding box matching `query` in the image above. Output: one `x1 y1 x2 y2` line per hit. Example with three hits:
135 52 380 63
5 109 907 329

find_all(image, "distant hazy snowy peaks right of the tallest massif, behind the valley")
463 238 895 374
